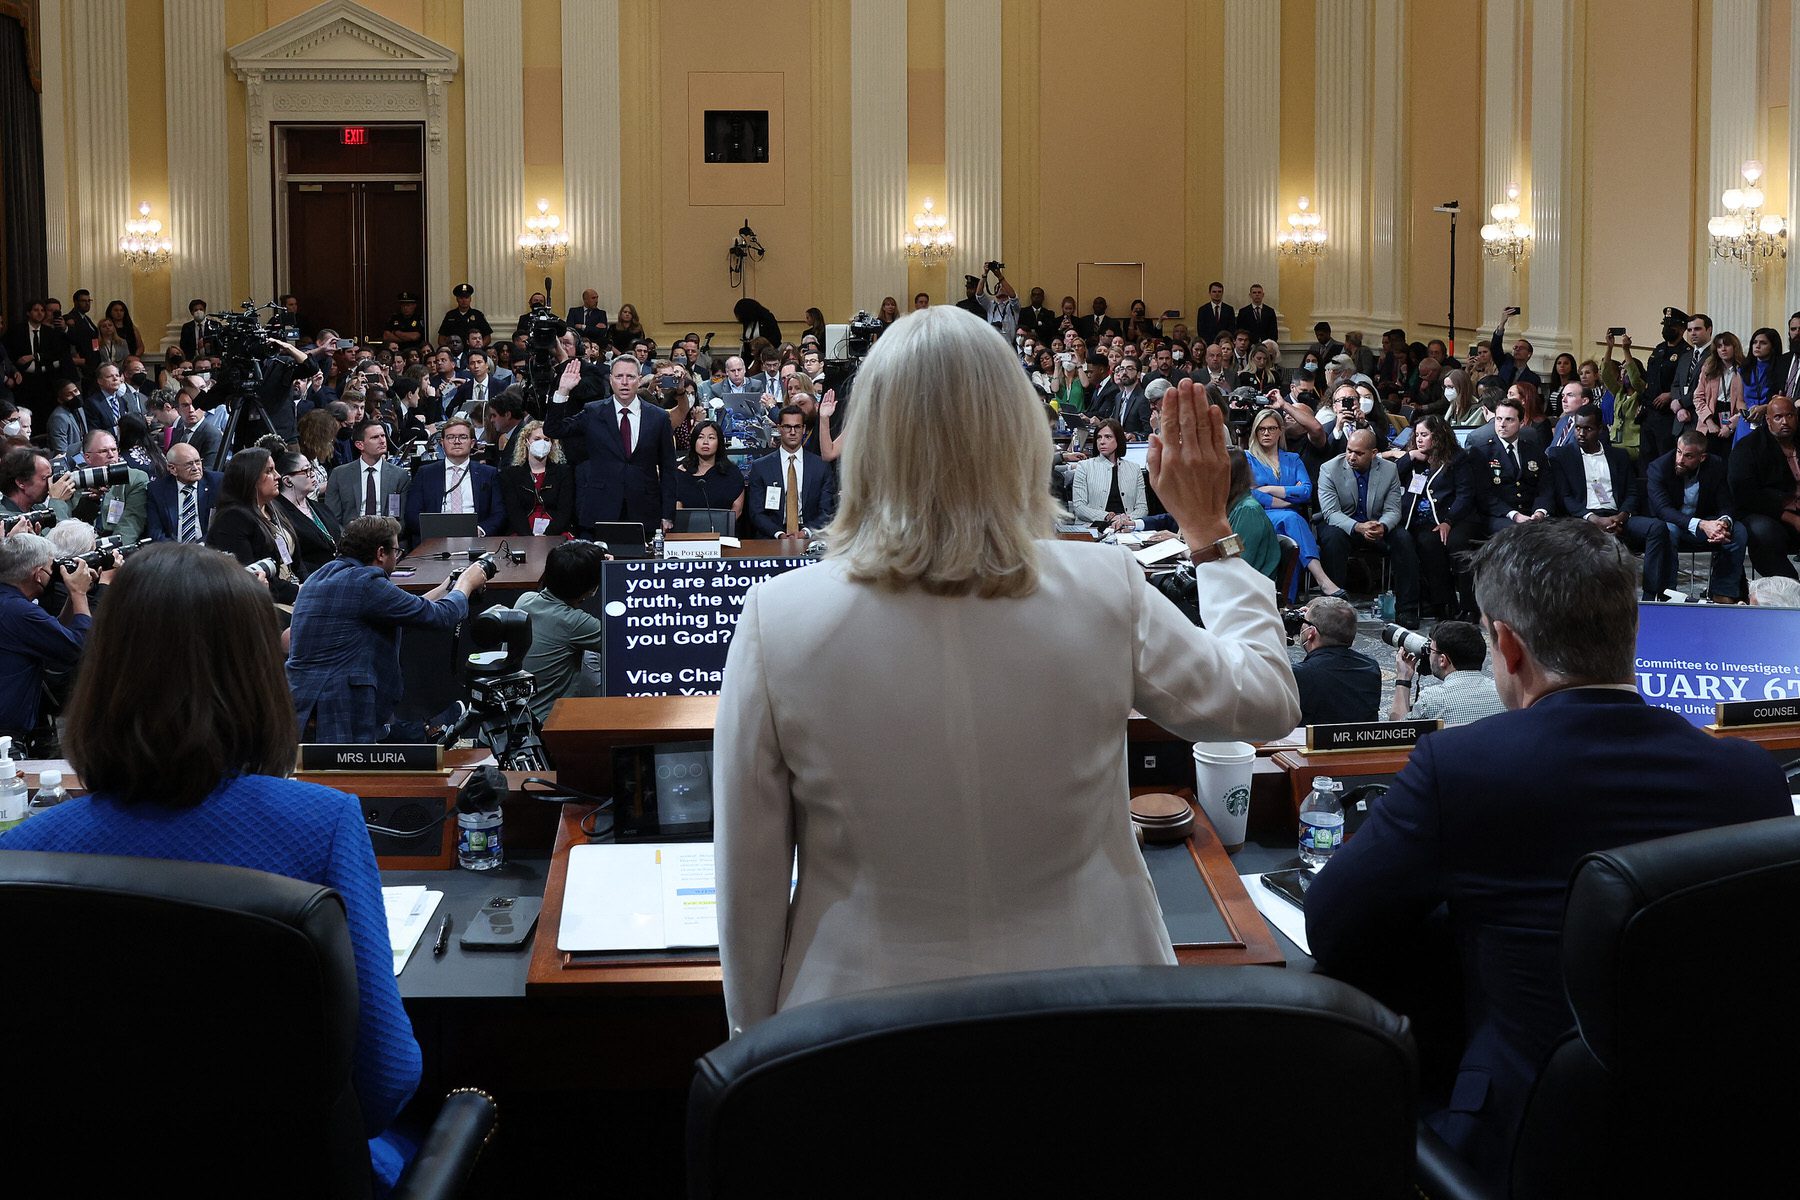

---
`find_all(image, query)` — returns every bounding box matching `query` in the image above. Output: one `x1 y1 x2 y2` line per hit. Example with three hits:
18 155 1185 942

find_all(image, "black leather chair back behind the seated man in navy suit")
1512 813 1800 1196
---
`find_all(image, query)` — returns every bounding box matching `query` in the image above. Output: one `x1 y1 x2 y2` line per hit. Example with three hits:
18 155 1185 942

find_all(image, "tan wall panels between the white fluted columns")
38 0 1791 345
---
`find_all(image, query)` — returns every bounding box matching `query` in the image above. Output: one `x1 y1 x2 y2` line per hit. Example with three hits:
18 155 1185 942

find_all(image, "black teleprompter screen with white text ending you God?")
599 558 812 696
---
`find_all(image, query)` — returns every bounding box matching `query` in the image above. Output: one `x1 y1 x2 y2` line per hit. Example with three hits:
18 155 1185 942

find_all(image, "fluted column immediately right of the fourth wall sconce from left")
1317 2 1368 329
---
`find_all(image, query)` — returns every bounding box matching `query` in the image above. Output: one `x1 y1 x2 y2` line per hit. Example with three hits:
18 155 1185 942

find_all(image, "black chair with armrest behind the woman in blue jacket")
0 849 493 1198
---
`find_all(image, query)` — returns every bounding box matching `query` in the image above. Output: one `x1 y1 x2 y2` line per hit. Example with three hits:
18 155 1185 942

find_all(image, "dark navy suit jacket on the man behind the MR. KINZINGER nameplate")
1296 690 1793 1178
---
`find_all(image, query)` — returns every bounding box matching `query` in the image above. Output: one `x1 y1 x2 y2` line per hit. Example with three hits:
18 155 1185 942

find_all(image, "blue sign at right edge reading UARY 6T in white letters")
1636 604 1800 725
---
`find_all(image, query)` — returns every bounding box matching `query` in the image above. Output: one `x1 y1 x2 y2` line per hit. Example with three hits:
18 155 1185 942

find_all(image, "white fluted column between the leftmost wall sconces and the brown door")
162 0 241 342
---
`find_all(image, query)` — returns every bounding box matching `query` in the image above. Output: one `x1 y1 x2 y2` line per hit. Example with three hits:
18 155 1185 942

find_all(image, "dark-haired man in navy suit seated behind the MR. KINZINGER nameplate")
1296 520 1793 1184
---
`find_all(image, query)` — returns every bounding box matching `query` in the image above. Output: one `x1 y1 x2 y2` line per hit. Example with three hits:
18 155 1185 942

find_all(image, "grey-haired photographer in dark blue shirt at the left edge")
0 533 94 757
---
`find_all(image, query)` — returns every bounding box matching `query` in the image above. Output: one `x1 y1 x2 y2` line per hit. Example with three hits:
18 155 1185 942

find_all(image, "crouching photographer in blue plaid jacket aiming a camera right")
288 516 493 745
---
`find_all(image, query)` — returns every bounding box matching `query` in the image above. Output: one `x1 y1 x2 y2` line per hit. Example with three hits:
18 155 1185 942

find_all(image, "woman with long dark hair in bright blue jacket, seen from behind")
0 542 421 1187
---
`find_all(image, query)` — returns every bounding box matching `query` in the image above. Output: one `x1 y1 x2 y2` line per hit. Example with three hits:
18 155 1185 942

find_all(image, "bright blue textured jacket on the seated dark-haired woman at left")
0 775 421 1189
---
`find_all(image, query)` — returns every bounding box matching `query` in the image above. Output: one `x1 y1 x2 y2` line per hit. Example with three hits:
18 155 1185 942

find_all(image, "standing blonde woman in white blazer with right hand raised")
715 306 1300 1031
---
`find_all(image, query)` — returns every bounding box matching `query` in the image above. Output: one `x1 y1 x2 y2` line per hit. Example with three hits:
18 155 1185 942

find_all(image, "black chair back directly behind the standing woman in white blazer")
688 966 1417 1198
